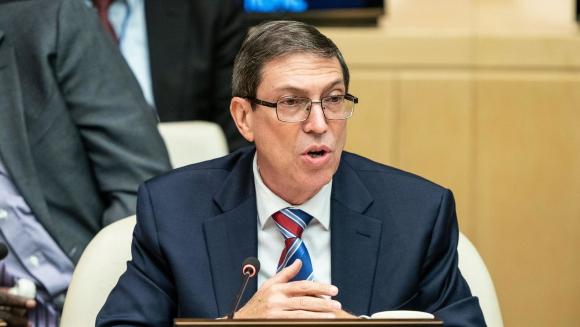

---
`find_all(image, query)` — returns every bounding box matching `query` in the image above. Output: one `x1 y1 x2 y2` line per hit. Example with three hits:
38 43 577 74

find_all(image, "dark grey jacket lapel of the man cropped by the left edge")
0 44 51 230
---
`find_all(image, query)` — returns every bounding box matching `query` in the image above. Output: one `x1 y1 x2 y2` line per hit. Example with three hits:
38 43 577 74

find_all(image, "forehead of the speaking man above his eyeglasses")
258 53 344 93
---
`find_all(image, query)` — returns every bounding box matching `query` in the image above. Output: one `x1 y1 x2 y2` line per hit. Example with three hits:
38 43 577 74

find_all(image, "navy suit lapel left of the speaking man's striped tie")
204 151 258 316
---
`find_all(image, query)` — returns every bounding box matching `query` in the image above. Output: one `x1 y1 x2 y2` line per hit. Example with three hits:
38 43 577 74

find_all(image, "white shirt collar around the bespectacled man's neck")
252 152 332 230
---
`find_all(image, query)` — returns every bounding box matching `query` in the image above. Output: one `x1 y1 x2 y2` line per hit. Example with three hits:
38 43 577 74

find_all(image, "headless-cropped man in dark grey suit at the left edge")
0 0 171 326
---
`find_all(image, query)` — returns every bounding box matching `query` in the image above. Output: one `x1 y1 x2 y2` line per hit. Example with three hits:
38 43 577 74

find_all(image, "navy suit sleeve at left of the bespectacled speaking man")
96 184 177 327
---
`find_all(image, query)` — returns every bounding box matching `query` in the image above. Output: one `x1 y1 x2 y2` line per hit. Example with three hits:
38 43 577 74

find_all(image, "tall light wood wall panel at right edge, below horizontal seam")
476 72 580 326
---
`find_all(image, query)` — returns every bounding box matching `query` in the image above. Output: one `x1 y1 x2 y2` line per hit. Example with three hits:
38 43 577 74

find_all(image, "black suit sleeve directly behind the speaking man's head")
212 0 250 151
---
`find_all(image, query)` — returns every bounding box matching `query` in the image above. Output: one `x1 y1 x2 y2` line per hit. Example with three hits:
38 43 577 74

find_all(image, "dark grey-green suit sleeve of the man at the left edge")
52 0 171 226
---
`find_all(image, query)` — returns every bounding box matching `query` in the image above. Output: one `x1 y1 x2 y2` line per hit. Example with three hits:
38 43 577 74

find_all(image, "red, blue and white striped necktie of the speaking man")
272 208 314 282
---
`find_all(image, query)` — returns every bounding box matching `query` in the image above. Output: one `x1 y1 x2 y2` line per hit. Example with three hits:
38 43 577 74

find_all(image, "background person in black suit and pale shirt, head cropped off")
93 0 249 151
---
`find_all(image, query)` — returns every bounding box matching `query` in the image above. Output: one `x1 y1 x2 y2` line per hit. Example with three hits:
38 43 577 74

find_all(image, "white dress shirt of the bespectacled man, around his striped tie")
253 154 332 287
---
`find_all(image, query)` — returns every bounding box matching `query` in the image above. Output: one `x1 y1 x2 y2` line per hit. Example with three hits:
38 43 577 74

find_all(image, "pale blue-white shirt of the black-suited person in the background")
109 0 155 107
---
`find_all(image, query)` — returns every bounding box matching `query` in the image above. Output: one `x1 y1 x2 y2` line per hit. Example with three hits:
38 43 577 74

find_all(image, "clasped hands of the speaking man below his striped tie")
234 260 355 319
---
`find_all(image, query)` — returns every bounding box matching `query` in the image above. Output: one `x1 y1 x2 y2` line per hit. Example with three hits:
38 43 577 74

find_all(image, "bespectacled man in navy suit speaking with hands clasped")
97 21 485 327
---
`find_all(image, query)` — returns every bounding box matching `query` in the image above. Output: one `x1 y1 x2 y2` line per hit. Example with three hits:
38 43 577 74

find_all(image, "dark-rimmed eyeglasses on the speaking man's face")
244 94 358 123
